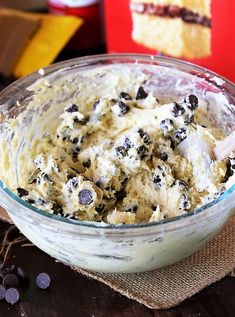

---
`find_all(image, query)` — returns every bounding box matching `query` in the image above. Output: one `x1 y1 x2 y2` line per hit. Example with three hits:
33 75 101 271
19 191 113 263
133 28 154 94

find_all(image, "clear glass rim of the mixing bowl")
0 53 235 229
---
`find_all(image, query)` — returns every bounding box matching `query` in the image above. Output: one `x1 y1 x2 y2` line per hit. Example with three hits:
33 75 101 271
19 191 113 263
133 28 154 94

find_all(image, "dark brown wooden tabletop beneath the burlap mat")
0 222 235 317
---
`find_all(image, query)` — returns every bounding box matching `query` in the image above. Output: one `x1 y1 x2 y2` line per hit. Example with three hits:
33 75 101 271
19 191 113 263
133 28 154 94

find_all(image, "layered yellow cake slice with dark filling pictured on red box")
130 0 211 58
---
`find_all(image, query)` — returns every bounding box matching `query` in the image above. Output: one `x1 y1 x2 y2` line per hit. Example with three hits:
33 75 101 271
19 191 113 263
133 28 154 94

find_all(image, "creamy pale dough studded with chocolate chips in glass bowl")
0 66 235 224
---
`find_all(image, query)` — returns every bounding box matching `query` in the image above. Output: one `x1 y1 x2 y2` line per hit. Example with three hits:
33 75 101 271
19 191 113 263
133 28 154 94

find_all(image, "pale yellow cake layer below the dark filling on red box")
132 12 211 58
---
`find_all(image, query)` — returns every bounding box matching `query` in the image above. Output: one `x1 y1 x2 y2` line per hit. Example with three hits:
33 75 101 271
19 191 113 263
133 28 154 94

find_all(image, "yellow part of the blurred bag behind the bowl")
12 10 83 78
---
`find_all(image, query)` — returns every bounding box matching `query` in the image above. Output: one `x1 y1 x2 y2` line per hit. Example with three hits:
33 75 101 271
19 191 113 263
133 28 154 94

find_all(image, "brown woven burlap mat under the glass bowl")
0 209 235 309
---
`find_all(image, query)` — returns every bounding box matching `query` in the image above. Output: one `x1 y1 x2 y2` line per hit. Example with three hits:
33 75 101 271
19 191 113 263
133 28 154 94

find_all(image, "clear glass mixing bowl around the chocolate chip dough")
0 54 235 273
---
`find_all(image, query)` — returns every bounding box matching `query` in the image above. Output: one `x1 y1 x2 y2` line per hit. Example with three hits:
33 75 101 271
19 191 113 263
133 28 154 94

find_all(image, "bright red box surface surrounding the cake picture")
104 0 235 82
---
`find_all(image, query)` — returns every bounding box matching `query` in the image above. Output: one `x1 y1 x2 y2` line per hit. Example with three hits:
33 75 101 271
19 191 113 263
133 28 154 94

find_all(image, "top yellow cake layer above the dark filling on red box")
132 0 211 17
